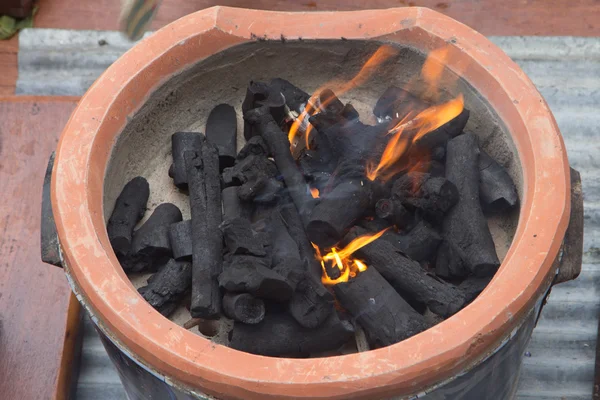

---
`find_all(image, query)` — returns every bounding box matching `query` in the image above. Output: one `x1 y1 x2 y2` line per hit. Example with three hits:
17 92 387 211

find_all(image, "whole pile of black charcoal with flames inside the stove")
107 42 519 357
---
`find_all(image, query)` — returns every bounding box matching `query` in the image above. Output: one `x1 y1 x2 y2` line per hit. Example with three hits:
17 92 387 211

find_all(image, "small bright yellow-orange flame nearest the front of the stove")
313 227 391 285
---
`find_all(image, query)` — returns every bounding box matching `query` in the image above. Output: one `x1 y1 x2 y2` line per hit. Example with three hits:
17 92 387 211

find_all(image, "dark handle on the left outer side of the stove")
40 152 62 267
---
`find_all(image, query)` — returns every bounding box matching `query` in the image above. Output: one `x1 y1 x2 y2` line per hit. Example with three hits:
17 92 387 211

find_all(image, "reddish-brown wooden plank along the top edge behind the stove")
35 0 600 36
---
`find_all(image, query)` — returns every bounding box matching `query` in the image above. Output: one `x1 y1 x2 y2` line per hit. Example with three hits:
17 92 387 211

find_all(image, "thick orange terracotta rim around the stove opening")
52 6 569 399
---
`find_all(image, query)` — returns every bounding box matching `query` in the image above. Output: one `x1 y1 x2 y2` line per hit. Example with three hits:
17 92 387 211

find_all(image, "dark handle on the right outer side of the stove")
554 168 583 284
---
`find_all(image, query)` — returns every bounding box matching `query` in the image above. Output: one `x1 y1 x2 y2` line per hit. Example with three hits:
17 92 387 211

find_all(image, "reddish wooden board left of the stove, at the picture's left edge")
0 96 79 399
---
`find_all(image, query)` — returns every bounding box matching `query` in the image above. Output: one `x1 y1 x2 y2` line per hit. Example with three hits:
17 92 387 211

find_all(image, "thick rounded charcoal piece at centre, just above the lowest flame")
306 179 371 248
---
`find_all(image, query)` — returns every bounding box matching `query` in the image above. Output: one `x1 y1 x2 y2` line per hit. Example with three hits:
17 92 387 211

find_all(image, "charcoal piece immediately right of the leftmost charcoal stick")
130 203 182 272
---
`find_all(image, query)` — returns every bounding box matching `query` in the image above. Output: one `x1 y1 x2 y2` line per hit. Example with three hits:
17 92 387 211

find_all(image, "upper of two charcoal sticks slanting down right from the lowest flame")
344 226 465 317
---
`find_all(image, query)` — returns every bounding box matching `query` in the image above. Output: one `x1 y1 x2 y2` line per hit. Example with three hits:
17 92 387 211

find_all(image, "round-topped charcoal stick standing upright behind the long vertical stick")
206 104 237 171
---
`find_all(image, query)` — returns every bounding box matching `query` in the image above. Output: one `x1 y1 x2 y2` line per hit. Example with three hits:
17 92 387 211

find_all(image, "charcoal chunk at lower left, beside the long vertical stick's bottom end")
138 259 192 317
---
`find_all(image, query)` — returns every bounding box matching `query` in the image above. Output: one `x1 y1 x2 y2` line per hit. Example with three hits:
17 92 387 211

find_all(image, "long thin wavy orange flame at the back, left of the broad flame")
288 45 398 149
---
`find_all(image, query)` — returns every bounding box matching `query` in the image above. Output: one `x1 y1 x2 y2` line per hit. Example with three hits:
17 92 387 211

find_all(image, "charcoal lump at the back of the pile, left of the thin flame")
242 82 286 140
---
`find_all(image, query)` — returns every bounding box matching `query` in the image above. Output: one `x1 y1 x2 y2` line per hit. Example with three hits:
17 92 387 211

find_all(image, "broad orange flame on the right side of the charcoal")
367 94 464 181
